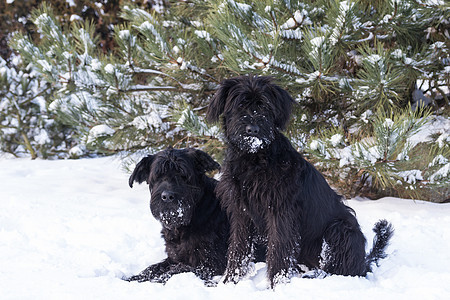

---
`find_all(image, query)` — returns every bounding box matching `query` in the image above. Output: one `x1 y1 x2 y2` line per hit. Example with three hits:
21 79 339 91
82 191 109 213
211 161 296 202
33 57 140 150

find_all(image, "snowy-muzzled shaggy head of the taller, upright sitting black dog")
207 76 294 153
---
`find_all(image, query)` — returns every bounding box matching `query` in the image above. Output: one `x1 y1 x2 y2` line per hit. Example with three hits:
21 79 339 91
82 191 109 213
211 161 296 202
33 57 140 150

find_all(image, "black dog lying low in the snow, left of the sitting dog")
127 148 229 283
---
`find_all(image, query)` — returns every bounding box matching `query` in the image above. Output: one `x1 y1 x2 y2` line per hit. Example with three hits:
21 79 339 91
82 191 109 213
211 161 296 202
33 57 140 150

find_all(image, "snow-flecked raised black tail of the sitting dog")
366 220 394 272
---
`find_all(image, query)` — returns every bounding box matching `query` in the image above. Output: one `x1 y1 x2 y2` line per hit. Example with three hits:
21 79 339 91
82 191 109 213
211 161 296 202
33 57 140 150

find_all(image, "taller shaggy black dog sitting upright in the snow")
207 76 393 287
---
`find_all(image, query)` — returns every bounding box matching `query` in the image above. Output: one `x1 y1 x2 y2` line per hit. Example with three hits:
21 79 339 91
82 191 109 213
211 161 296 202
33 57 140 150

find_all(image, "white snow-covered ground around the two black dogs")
0 158 450 300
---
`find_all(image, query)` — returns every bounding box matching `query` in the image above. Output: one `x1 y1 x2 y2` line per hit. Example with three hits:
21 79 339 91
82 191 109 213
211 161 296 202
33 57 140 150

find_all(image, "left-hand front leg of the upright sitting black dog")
224 210 253 283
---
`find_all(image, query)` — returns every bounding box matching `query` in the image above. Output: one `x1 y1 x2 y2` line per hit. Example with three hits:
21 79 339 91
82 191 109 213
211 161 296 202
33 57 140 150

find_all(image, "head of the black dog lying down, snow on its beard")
129 148 220 230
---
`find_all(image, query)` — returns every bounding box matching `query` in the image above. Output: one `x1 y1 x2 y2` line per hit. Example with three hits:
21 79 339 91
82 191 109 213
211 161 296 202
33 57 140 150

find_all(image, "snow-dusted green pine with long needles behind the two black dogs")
7 0 450 201
